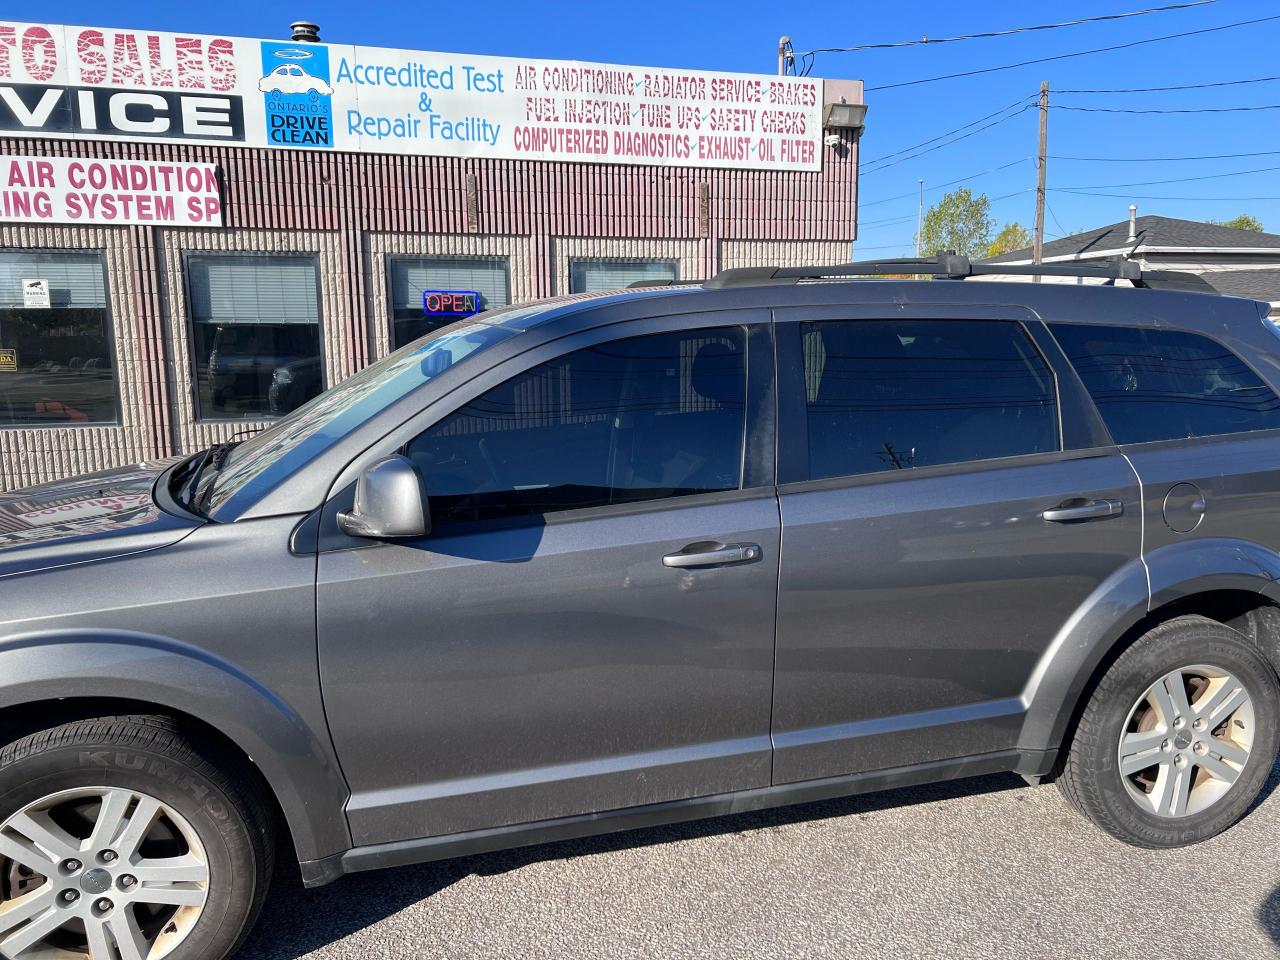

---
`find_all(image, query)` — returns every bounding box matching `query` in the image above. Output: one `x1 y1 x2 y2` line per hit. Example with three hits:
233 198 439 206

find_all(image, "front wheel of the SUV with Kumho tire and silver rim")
0 717 275 960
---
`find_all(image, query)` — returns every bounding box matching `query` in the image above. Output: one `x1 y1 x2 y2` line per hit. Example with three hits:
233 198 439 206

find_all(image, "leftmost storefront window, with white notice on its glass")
0 250 116 426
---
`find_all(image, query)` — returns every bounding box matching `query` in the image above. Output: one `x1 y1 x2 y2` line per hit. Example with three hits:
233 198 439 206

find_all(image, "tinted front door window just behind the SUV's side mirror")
406 328 746 525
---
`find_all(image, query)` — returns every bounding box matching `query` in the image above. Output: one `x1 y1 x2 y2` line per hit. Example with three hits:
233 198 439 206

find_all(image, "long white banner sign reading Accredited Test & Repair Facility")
0 20 822 170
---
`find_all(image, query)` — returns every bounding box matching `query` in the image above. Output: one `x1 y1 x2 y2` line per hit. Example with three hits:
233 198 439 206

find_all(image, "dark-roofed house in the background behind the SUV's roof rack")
983 206 1280 317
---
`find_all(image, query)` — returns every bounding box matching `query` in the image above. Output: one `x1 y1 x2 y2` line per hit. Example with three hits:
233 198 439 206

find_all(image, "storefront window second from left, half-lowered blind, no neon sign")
187 255 324 420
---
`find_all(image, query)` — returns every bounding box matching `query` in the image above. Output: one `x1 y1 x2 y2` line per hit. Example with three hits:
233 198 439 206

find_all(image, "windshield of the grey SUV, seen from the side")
193 312 535 518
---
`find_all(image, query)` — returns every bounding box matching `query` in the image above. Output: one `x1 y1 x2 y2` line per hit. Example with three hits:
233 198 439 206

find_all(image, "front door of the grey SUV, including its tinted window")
317 311 780 844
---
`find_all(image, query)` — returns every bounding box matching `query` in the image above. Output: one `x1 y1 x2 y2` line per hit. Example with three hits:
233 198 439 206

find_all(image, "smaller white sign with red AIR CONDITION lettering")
0 156 223 227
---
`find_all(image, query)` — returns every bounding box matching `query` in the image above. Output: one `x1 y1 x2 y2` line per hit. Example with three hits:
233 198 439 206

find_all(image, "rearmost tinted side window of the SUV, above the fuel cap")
1051 324 1280 443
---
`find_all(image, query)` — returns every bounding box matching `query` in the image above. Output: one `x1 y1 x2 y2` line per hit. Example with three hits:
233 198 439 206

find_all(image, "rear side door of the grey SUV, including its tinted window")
773 306 1142 783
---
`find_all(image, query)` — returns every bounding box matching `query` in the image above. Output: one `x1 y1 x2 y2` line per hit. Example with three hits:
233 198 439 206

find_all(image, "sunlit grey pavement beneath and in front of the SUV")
241 767 1280 960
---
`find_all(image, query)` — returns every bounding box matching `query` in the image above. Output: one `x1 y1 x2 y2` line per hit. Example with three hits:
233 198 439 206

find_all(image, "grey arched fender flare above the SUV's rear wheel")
1019 538 1280 755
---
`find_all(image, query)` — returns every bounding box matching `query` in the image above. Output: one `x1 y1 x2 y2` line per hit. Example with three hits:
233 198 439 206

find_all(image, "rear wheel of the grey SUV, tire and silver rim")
1057 616 1280 849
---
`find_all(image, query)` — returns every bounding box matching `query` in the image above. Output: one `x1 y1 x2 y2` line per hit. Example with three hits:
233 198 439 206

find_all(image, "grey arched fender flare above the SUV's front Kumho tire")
0 631 351 860
